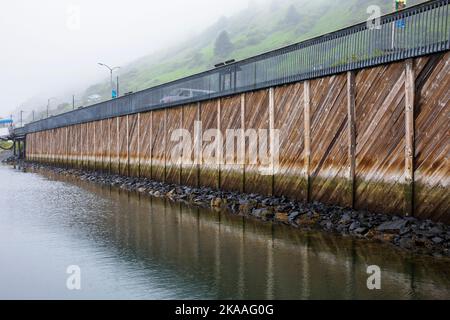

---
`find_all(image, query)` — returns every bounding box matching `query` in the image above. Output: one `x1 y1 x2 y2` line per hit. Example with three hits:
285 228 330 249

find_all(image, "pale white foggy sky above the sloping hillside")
0 0 253 117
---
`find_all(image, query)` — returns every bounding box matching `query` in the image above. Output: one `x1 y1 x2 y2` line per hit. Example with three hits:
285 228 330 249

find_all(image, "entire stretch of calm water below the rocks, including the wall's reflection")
0 166 450 299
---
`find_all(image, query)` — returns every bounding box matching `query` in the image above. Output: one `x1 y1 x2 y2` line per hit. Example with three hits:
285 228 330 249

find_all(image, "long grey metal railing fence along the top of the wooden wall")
15 0 450 135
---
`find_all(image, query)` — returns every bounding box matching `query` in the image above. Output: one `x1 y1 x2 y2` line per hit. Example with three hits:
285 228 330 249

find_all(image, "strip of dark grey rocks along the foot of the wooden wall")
3 158 450 257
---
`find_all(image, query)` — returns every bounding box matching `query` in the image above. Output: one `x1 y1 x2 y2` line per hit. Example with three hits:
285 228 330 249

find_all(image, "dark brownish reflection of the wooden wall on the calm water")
34 170 450 299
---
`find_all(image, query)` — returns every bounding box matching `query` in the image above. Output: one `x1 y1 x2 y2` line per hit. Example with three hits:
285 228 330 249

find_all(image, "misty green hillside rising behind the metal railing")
74 0 424 111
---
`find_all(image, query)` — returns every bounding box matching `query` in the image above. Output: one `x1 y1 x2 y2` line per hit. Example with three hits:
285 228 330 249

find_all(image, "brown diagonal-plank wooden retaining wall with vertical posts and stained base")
26 52 450 223
